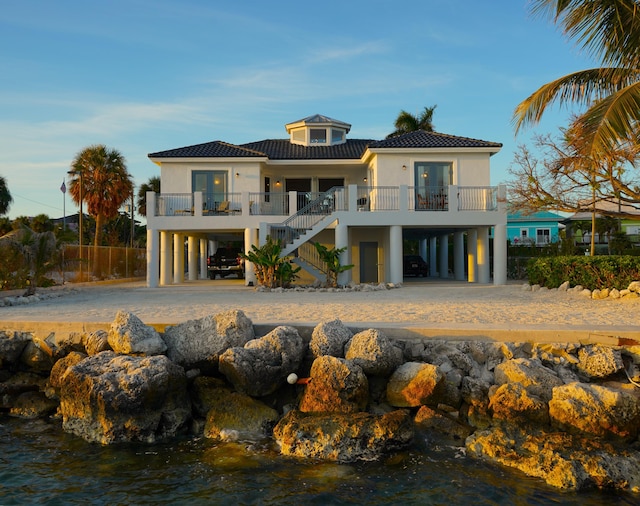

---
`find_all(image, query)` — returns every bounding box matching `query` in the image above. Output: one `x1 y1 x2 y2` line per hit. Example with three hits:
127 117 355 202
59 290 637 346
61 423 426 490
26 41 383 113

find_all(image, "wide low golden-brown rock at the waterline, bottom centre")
273 410 414 462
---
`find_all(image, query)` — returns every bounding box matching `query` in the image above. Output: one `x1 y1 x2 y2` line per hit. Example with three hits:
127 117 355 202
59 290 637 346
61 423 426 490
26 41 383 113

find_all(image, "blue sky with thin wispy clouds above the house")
0 0 596 218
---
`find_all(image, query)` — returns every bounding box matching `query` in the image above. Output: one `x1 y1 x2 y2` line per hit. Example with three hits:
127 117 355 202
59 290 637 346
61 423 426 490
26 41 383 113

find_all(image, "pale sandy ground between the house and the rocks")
0 280 640 342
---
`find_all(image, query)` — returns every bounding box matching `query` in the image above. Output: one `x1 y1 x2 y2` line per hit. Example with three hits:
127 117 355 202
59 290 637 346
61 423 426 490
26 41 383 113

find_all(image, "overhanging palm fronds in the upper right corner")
513 0 640 153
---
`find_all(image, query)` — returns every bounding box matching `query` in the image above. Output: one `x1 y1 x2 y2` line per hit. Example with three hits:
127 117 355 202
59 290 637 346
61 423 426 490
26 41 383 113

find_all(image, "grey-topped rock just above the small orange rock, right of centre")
495 358 563 402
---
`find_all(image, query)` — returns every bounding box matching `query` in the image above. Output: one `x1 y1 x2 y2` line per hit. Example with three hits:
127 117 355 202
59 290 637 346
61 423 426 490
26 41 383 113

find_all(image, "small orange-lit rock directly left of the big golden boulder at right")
489 383 549 426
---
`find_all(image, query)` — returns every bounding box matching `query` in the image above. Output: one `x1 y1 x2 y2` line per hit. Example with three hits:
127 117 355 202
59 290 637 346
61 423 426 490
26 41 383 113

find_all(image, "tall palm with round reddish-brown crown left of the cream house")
69 144 133 247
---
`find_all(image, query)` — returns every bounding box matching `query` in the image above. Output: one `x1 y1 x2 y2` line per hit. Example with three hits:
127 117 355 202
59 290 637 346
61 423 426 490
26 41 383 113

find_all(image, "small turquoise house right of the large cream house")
507 211 564 246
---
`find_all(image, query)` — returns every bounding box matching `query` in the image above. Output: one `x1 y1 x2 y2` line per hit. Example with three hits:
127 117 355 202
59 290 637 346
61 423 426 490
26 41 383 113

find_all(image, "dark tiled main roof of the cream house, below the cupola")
148 130 502 160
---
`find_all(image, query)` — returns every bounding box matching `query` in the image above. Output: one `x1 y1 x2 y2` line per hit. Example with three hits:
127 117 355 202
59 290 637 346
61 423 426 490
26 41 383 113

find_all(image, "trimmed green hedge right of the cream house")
527 255 640 290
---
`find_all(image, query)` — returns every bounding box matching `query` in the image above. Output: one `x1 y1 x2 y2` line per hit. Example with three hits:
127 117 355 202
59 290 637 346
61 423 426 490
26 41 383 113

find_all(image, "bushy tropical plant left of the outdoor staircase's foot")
240 236 300 288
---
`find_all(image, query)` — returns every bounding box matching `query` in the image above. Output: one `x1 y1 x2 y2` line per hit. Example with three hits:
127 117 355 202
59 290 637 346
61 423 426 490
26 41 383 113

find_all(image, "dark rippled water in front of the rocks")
0 417 640 506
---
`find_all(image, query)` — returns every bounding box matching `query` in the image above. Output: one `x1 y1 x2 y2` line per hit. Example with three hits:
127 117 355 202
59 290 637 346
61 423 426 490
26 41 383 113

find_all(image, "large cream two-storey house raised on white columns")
147 115 507 287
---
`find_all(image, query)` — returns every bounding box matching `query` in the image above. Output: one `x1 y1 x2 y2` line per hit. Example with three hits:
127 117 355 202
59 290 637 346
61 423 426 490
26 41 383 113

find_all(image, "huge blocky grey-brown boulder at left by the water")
60 351 191 444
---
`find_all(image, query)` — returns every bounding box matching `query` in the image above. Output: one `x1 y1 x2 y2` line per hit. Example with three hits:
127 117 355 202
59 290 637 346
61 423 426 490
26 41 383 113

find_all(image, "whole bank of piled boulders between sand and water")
0 310 640 493
